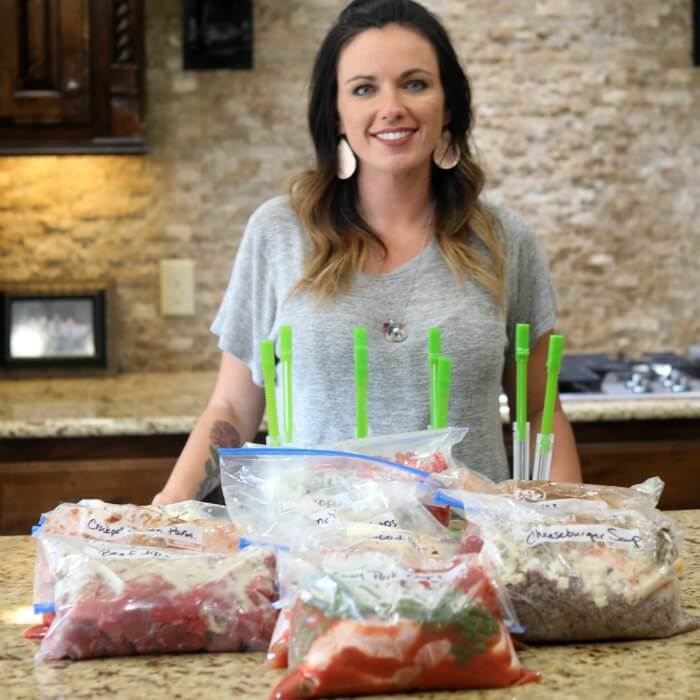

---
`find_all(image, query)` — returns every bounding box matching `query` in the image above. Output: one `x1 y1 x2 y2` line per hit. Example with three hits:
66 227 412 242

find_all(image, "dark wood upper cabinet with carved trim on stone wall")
0 0 146 155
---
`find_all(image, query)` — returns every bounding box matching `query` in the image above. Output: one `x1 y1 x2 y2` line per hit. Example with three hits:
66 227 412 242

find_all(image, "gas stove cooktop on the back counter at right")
559 353 700 400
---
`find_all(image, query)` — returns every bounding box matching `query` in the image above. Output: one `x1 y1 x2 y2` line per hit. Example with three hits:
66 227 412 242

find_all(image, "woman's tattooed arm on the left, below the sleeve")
153 352 265 505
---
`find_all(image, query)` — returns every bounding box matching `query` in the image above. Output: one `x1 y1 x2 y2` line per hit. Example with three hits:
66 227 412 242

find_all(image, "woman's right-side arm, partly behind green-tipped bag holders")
503 331 581 483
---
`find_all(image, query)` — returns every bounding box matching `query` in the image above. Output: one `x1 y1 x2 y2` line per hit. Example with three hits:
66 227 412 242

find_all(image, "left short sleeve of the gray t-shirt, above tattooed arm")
211 205 277 386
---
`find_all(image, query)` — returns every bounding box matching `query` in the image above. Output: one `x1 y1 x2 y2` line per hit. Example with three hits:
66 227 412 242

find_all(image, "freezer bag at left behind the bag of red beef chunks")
31 500 239 636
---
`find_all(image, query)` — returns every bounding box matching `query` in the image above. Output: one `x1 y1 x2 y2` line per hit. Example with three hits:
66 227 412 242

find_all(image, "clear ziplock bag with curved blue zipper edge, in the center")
219 448 434 543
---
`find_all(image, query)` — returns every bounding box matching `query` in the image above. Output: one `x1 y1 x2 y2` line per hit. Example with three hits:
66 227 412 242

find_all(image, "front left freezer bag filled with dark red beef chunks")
37 533 277 660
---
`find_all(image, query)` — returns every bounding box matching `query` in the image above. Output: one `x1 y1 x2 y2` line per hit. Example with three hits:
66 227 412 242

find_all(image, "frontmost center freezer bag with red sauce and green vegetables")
270 550 538 698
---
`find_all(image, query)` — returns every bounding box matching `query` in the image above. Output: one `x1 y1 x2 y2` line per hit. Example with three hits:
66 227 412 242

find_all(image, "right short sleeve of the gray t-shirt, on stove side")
497 208 556 365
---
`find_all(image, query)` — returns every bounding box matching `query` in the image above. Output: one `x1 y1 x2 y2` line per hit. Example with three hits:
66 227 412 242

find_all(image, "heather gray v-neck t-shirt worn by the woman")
211 197 555 480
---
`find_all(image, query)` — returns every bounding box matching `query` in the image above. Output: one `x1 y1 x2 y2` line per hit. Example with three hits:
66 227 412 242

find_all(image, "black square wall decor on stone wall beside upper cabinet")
182 0 253 70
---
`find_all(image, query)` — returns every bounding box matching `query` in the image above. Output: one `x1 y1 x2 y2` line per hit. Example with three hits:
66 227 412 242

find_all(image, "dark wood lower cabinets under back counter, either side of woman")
0 419 700 535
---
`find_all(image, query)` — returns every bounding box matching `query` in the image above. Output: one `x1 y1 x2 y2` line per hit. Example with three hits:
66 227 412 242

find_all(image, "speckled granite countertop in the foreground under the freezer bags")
0 511 700 700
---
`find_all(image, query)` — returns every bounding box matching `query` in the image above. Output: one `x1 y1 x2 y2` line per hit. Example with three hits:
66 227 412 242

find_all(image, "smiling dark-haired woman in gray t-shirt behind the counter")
154 0 580 503
